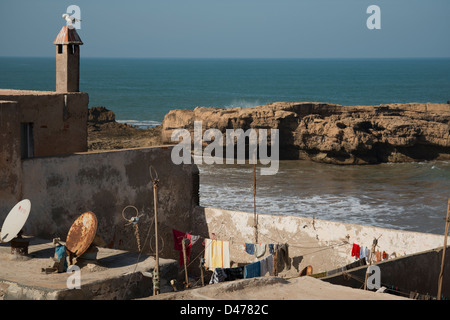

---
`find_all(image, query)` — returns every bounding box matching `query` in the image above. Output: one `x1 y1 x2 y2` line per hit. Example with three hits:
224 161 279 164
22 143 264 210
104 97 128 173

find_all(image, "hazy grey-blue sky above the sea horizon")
0 0 450 58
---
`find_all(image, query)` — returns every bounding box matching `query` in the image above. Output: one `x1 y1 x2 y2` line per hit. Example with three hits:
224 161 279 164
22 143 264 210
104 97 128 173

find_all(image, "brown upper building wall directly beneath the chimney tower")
0 89 89 157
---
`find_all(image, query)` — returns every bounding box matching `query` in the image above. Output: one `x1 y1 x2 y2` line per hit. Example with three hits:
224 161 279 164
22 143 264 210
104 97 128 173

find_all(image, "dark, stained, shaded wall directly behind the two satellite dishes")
13 147 198 257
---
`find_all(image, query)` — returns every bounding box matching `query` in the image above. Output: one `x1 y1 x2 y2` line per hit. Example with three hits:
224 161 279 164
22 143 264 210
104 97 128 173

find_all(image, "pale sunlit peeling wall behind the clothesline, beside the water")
192 207 444 275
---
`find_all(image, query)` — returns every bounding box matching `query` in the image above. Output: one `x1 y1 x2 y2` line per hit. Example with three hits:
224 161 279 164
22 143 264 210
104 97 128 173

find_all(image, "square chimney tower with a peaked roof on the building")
53 15 83 92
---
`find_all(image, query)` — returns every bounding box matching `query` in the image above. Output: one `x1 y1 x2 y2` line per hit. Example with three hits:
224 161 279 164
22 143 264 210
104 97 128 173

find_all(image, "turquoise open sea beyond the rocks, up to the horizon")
0 57 450 122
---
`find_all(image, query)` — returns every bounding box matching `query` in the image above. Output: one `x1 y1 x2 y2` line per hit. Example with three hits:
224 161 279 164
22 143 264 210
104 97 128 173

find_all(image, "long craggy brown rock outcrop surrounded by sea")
161 102 450 164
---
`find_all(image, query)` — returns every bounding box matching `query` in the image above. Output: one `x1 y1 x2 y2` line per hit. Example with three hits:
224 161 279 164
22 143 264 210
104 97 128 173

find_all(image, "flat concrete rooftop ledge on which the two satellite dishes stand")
0 238 178 300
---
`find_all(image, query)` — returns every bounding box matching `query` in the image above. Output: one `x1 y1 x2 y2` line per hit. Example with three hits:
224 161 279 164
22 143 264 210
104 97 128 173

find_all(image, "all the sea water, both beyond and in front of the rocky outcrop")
0 57 450 234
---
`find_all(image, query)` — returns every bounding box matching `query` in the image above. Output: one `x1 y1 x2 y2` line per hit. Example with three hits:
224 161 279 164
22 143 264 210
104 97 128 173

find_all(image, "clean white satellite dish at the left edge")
0 199 31 242
